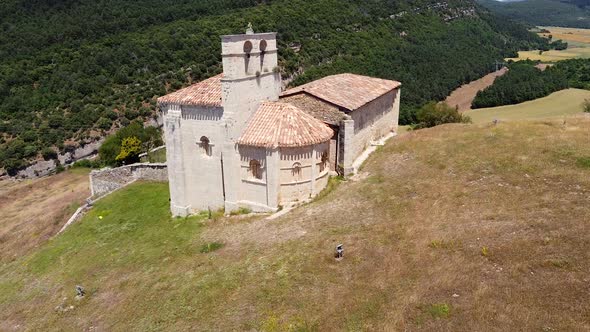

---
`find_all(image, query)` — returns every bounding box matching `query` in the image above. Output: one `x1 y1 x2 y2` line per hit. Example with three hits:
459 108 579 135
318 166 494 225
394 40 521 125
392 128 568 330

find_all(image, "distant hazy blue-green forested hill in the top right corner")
477 0 590 28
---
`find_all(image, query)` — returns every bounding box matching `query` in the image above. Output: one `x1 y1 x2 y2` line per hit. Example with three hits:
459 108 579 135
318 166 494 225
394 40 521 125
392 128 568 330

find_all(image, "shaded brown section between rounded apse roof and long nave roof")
281 93 345 126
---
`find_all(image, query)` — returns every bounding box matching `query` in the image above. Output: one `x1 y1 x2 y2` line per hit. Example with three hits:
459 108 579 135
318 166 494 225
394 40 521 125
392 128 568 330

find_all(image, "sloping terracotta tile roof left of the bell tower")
158 74 223 107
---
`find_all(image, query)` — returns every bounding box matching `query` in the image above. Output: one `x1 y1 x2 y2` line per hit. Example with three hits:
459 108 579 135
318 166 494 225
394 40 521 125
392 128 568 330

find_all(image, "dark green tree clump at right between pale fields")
473 59 590 108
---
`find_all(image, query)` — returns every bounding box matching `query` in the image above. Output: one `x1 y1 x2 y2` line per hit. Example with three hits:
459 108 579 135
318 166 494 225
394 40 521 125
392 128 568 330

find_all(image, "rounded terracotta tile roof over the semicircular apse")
238 102 334 148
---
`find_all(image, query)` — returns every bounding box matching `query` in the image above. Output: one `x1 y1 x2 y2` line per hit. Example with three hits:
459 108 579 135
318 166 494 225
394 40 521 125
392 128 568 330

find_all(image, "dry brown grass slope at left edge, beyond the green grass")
0 170 90 263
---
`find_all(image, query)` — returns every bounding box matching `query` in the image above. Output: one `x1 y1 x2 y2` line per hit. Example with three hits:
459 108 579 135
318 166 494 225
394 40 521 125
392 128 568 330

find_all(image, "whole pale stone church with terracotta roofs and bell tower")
158 27 401 216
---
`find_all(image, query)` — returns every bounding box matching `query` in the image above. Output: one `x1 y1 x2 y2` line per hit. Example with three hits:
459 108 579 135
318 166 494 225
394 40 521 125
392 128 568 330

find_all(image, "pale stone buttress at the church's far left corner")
164 105 190 217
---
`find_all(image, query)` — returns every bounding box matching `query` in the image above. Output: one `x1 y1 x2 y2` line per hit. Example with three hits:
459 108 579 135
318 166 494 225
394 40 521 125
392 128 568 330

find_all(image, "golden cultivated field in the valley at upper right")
506 27 590 62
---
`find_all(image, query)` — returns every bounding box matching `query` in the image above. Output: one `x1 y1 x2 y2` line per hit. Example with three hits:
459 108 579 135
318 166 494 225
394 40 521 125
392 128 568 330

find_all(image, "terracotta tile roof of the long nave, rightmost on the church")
282 74 401 111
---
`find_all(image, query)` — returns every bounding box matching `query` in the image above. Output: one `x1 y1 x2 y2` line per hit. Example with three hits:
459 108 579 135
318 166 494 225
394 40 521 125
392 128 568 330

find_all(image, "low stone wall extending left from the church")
90 163 168 198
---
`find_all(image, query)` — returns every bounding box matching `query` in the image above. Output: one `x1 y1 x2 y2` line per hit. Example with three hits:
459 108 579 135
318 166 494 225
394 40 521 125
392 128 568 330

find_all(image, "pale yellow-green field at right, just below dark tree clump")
465 89 590 123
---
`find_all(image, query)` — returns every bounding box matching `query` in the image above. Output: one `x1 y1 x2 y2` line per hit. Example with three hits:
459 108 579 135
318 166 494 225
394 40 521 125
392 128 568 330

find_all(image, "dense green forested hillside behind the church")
0 0 547 174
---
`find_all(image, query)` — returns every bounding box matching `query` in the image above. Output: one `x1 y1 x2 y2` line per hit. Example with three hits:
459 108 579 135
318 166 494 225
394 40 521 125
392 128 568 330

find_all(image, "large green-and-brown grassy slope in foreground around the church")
0 118 590 331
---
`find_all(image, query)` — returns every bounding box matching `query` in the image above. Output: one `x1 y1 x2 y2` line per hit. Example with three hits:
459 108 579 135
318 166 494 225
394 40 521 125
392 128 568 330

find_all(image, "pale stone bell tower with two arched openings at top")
221 24 281 211
